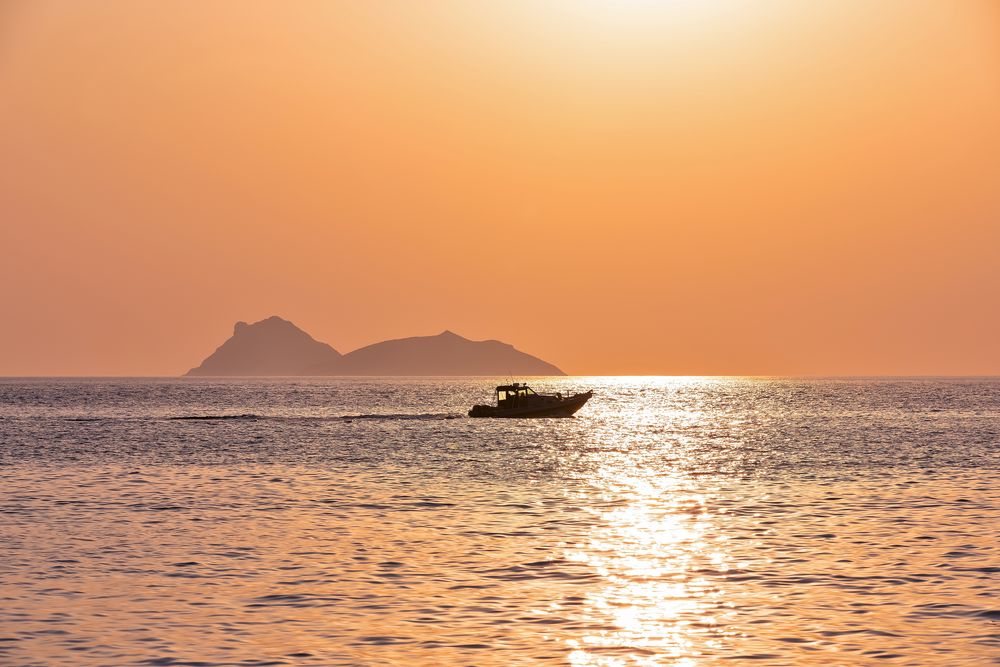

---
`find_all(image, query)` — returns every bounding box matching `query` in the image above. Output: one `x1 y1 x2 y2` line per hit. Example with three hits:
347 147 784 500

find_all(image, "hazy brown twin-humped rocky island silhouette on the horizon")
185 316 565 376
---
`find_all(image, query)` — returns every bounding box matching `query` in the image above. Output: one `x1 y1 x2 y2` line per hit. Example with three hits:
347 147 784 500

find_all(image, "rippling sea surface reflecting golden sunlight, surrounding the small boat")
0 378 1000 667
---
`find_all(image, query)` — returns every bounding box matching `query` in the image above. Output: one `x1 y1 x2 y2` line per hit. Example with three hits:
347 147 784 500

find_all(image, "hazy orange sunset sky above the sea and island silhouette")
0 0 1000 375
